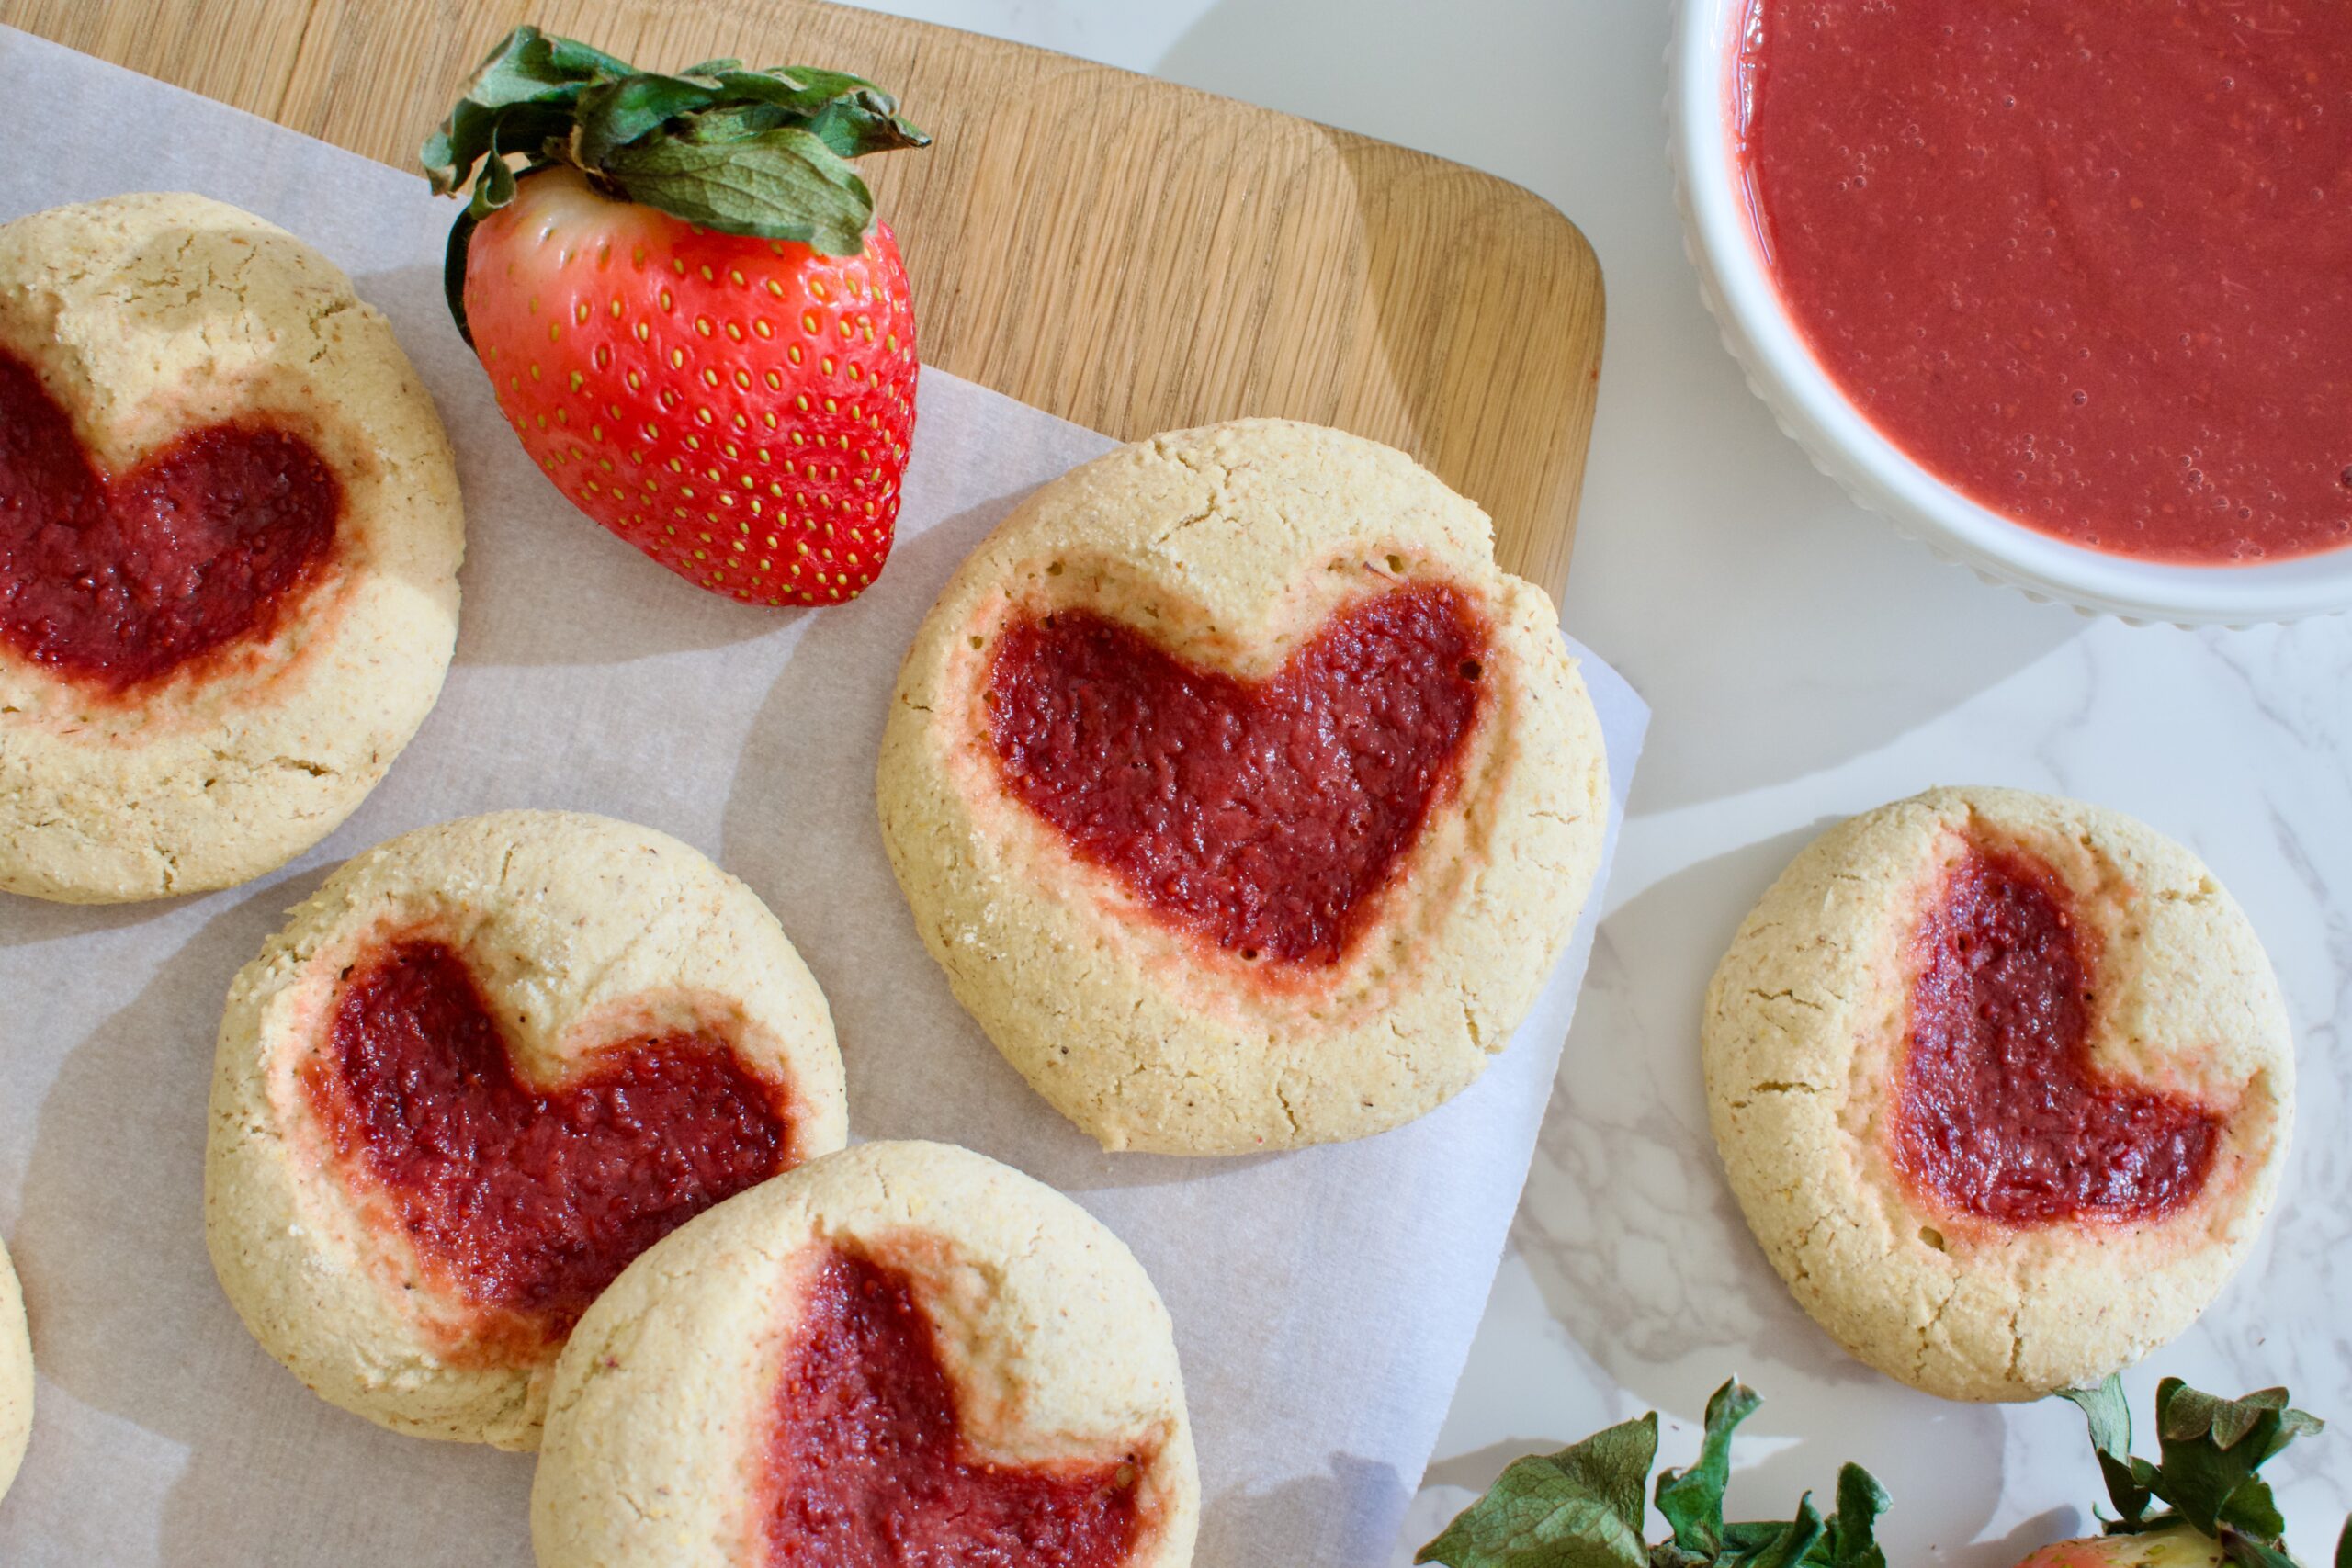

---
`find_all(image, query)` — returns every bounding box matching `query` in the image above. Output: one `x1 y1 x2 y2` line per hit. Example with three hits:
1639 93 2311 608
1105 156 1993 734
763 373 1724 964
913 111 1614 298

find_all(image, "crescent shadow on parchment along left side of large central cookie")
719 496 1277 1194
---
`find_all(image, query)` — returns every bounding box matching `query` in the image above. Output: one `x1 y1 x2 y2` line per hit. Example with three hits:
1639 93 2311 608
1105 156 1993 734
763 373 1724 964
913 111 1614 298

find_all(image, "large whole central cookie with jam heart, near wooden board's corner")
879 421 1609 1155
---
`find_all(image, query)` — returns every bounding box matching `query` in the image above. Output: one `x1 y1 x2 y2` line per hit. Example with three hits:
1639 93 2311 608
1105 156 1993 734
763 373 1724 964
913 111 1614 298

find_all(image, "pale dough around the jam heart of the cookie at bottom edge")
532 1143 1200 1568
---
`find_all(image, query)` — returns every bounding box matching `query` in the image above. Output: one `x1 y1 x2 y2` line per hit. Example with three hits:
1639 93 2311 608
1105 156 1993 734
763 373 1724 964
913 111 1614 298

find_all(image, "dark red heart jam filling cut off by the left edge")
0 353 344 694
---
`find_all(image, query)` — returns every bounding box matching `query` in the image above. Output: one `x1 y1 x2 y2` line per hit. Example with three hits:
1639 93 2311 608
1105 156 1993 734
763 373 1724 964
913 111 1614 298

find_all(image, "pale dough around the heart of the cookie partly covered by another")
205 811 847 1448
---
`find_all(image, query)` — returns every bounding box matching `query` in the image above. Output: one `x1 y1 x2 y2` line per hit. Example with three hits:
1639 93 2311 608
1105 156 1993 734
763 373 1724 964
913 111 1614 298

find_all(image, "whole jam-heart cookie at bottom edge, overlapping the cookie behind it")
532 1143 1200 1568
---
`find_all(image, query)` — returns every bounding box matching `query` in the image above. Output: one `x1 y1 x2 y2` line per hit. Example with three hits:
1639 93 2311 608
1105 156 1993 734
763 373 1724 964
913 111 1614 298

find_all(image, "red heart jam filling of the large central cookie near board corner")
988 583 1487 966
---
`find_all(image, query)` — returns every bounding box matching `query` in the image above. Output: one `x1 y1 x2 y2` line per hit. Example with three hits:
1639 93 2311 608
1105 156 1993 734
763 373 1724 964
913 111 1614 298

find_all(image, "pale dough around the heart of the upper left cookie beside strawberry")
0 195 463 903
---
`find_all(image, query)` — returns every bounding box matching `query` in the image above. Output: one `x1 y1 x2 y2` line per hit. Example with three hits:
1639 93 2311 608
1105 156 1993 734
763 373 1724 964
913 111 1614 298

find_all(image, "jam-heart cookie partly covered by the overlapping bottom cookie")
205 811 847 1448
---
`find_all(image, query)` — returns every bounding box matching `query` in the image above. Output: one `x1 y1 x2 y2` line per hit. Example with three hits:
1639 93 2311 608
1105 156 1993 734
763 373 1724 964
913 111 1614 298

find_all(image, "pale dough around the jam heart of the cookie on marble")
1702 790 2296 1399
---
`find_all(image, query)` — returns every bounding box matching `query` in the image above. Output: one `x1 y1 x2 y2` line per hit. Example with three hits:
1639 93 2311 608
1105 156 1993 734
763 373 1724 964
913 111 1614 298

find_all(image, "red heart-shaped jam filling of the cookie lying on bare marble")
1894 849 2222 1224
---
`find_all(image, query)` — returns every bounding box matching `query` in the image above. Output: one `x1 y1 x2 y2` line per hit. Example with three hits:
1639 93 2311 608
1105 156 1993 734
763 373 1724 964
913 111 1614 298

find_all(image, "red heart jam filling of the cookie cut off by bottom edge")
767 1248 1143 1568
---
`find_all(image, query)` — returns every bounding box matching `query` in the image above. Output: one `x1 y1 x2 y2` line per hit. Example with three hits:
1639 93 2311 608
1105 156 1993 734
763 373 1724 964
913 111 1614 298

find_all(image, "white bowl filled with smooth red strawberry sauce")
1672 0 2352 623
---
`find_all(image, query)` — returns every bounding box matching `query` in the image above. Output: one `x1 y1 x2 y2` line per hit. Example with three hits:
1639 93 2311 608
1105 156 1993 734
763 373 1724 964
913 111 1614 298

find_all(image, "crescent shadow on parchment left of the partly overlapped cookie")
14 865 529 1568
